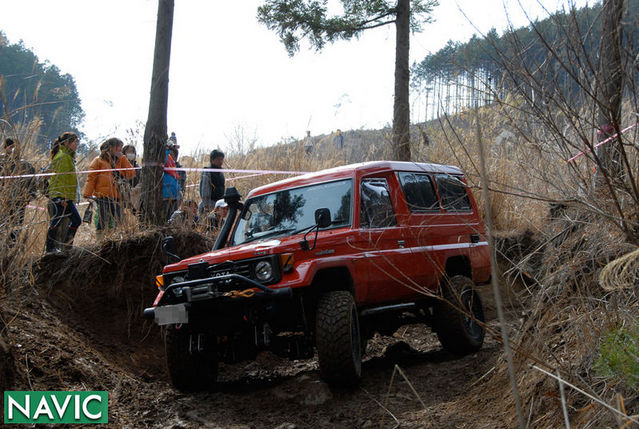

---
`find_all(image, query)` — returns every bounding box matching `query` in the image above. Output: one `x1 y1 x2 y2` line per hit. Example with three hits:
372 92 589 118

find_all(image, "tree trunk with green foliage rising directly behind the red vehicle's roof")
392 0 410 161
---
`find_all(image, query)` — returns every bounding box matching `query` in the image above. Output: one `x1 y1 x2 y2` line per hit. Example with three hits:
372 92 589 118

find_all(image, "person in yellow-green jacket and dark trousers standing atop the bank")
45 132 82 253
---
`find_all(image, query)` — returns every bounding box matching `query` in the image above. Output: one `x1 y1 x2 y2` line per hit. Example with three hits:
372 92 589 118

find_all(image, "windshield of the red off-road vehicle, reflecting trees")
232 179 353 245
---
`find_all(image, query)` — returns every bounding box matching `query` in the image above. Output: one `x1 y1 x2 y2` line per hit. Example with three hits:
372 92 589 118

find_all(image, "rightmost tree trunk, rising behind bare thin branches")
595 0 623 189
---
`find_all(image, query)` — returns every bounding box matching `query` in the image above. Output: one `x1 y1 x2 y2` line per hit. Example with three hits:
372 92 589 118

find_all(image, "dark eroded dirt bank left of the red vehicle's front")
0 232 212 390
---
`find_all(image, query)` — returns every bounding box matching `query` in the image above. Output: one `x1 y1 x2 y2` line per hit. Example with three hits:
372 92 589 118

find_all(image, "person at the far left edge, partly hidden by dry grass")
0 138 37 247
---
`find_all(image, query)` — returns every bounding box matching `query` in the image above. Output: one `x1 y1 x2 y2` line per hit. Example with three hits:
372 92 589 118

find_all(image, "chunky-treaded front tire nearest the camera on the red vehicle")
315 291 362 387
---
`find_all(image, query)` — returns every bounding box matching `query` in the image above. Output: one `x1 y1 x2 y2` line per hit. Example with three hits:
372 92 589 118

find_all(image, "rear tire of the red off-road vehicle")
435 276 485 355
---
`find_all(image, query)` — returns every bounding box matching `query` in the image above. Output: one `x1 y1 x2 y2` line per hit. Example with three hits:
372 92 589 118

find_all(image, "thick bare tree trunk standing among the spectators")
142 0 174 225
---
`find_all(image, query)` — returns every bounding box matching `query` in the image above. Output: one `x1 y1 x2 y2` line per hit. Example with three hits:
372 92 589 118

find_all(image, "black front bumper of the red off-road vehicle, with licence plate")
143 274 293 325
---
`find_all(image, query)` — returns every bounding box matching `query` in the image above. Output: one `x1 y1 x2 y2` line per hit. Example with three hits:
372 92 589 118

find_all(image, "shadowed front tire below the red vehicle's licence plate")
164 325 217 391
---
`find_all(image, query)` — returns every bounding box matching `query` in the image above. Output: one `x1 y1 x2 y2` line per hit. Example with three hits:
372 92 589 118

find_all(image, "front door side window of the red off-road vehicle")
360 179 397 228
